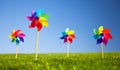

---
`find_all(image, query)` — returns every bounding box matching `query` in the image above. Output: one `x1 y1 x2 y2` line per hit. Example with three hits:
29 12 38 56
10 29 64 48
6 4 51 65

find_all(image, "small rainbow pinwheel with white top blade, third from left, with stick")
60 28 76 57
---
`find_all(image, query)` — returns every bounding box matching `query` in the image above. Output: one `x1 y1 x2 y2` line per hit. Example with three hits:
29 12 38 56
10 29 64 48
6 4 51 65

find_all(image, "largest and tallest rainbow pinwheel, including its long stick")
27 9 49 60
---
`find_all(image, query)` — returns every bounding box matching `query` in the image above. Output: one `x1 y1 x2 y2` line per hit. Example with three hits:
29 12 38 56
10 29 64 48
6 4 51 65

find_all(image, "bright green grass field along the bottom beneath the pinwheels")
0 52 120 70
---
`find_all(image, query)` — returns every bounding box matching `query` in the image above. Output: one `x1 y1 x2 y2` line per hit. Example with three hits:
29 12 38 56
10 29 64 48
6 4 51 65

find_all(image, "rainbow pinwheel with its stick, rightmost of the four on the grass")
93 26 112 58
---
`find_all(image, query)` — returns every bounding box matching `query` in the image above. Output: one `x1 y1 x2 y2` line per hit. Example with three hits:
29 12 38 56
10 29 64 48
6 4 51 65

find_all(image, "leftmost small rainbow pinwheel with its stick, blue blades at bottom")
9 30 25 58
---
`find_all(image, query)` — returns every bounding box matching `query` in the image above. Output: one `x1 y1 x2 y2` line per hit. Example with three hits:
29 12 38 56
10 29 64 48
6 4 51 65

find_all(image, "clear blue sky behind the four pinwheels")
0 0 120 53
